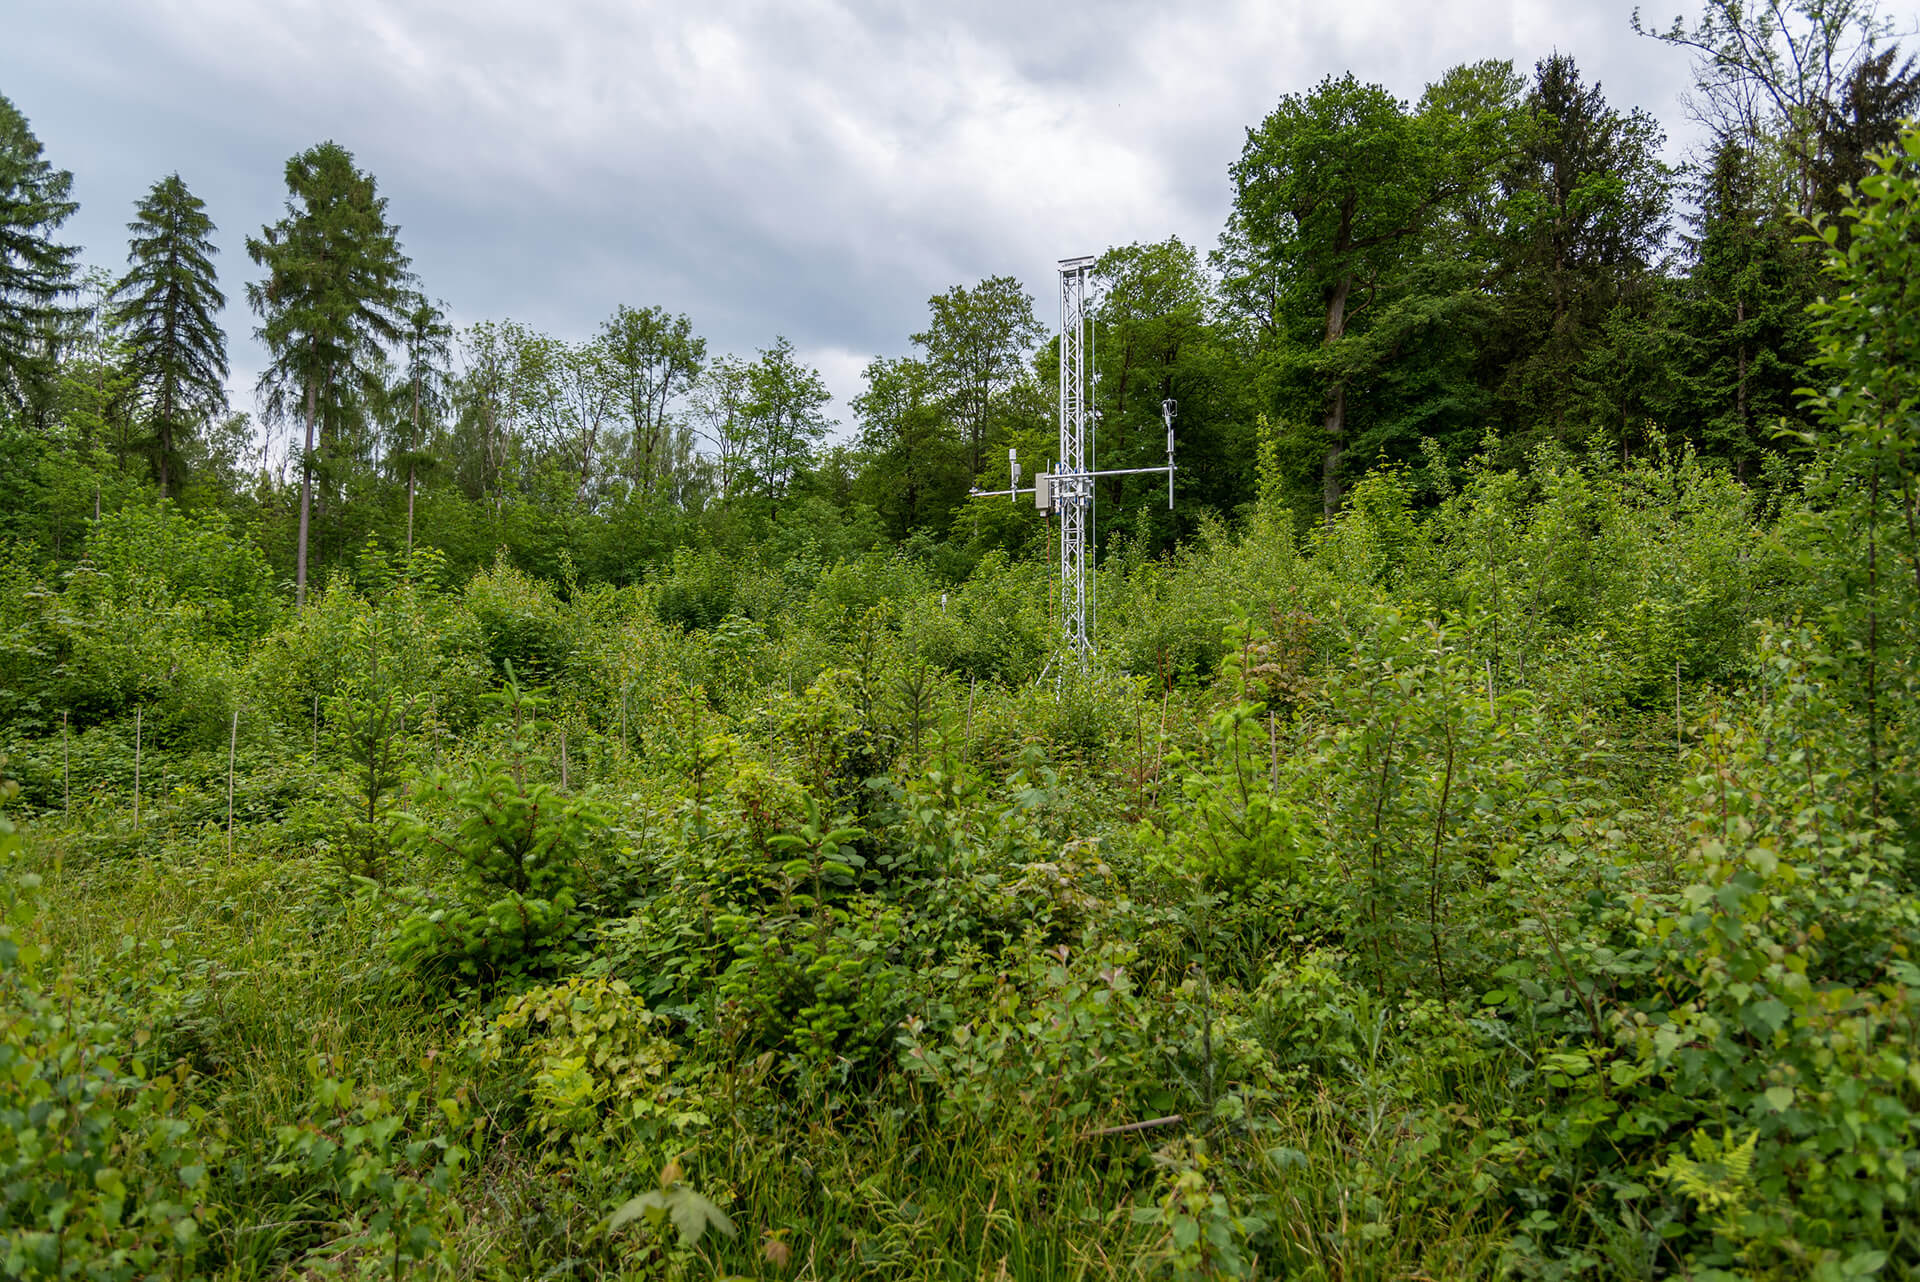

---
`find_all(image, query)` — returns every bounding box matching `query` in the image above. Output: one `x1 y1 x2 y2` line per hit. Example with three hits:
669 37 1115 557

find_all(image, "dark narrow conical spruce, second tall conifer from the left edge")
113 175 227 495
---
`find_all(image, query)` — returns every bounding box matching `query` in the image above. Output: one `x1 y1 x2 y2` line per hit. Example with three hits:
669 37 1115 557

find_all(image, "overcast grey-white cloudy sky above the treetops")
0 0 1914 429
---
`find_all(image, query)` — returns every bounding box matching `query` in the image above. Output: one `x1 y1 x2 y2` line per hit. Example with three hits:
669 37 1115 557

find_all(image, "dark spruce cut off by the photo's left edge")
0 96 79 416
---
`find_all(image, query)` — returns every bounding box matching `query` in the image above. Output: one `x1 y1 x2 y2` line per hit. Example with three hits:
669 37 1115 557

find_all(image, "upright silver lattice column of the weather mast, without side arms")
1050 257 1096 660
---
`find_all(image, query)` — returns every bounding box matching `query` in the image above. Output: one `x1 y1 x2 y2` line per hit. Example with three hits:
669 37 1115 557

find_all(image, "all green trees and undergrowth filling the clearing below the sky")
0 0 1920 1282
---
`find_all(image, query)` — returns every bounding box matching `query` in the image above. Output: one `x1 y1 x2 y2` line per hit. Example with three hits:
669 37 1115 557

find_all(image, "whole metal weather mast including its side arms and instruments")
970 257 1179 664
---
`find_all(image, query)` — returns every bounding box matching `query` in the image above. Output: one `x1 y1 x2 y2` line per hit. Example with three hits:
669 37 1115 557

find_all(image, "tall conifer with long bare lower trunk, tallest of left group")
246 142 411 605
